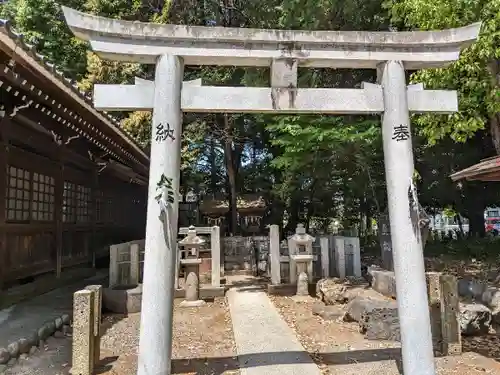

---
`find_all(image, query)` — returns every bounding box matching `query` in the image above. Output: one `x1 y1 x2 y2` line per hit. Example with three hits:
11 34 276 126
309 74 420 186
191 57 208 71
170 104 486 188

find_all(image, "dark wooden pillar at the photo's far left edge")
0 114 10 291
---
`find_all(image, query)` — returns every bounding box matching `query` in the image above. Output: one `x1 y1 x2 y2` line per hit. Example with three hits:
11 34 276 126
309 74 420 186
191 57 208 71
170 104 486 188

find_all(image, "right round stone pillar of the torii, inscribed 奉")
380 61 436 375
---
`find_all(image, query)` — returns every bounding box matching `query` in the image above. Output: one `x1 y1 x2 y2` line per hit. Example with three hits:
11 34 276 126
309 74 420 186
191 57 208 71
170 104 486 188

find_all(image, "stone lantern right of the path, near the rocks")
288 224 315 296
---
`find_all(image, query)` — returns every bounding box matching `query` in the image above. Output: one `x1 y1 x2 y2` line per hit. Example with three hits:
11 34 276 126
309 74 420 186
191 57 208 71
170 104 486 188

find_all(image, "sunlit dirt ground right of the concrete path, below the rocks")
271 296 500 375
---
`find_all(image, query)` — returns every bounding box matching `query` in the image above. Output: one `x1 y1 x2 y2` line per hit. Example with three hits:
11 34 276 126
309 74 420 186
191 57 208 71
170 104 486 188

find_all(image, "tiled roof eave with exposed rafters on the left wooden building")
0 20 149 177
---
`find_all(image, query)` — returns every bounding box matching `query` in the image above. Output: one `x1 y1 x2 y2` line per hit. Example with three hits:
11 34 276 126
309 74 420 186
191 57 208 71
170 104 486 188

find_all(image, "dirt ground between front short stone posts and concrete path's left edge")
98 298 239 375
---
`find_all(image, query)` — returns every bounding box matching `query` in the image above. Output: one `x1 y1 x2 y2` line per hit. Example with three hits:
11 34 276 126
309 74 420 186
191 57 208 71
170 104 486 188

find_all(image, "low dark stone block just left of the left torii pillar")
102 284 142 314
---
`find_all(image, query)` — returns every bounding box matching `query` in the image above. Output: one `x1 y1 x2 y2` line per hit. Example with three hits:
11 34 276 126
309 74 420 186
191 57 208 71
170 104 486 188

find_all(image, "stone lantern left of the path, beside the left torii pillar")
179 226 205 307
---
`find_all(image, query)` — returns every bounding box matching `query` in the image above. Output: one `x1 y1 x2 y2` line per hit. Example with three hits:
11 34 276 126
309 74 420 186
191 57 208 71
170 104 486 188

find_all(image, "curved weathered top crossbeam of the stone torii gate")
63 7 481 70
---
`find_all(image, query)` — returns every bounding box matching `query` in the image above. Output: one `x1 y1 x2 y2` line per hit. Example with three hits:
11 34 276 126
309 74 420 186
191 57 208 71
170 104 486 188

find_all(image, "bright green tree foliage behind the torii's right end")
385 0 500 147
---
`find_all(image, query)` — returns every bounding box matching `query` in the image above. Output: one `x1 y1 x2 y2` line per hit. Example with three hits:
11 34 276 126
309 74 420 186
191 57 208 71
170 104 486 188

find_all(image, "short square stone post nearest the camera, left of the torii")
71 290 96 375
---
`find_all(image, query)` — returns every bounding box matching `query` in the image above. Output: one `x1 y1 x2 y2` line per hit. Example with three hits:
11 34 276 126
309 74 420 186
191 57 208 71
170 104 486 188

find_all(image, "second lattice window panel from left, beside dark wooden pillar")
31 172 55 221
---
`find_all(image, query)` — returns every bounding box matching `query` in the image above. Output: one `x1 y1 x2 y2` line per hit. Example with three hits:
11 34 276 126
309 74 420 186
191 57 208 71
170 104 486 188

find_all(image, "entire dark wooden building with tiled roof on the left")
0 21 149 290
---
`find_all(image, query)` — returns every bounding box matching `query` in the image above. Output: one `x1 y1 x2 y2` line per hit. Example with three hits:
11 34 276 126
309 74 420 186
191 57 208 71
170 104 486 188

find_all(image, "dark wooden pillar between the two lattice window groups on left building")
54 145 64 278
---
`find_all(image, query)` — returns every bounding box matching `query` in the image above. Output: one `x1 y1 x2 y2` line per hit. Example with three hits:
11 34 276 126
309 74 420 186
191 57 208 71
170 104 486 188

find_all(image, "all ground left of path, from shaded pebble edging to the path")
0 298 239 375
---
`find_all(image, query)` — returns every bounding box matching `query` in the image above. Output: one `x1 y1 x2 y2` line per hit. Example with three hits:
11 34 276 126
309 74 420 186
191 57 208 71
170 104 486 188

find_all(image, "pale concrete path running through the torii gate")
227 287 320 375
